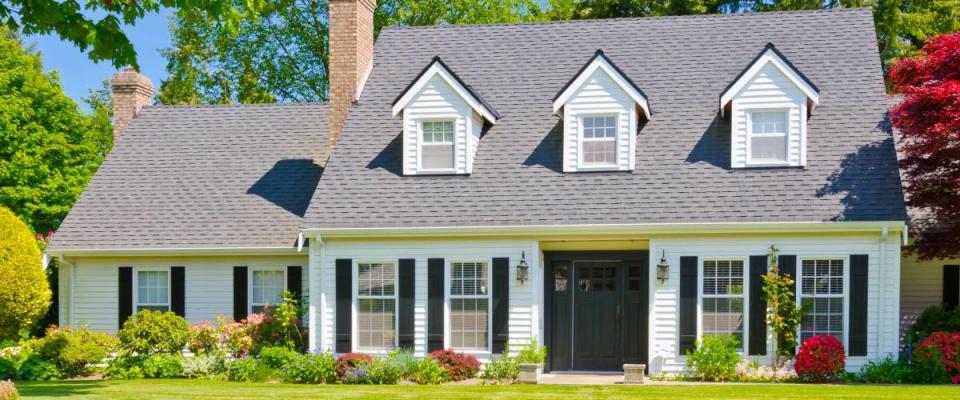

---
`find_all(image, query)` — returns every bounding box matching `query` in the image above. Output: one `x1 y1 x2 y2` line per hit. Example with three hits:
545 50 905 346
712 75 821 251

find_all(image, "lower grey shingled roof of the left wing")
51 103 327 250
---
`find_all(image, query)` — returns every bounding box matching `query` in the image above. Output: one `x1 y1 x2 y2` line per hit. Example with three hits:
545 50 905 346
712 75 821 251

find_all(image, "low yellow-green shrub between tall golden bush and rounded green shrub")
33 327 117 377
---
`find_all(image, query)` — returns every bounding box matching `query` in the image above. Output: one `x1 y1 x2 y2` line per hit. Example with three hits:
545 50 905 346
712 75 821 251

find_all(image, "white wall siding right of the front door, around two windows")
649 232 900 374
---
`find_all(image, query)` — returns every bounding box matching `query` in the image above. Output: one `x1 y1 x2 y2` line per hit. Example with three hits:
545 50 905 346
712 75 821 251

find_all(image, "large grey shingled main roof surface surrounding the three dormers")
304 9 906 228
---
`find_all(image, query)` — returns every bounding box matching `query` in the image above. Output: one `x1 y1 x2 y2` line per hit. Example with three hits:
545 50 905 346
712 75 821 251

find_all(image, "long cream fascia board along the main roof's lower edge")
303 221 906 239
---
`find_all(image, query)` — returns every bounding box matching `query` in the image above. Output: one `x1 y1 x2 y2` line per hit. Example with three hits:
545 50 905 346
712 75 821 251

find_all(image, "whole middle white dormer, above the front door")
553 50 650 172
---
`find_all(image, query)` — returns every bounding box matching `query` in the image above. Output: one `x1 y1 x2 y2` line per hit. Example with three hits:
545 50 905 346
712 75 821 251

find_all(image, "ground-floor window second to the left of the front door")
357 262 397 350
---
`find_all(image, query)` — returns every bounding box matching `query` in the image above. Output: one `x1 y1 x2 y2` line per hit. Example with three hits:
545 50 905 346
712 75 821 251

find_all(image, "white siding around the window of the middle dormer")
563 69 637 172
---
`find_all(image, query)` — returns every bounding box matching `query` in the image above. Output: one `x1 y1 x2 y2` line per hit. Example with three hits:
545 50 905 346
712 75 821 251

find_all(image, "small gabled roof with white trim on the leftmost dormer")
391 56 501 124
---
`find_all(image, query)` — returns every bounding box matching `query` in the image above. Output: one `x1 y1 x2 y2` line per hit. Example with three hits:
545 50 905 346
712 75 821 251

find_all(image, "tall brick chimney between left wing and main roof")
327 0 377 151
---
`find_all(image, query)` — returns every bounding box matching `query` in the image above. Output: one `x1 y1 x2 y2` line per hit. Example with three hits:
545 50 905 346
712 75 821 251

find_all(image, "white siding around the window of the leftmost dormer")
403 75 474 175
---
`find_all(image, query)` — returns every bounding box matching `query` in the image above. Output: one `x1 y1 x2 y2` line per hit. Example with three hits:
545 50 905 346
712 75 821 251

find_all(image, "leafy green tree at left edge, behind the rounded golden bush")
0 28 113 232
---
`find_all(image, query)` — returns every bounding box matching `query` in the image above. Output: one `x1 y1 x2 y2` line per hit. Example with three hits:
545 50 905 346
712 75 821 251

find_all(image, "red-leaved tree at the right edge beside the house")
890 32 960 259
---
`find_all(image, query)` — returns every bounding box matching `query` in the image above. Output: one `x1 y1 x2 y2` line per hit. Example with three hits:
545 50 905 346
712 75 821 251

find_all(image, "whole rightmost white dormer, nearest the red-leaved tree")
720 44 820 168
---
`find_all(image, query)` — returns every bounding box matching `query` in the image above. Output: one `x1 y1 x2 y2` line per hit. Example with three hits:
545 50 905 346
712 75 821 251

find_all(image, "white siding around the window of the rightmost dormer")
730 63 807 168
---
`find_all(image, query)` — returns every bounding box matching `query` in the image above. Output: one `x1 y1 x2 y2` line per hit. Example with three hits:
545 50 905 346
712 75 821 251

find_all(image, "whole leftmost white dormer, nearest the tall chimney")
393 57 500 175
